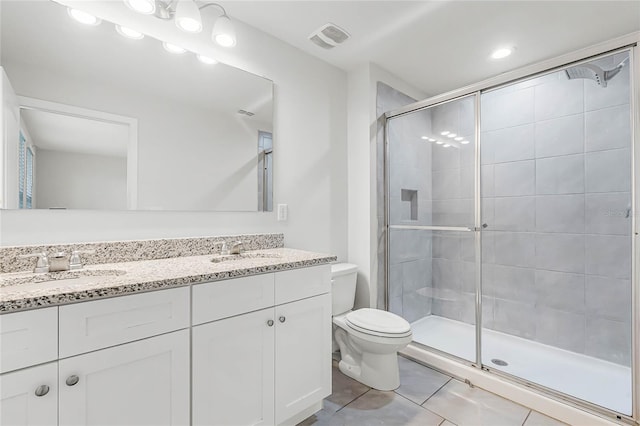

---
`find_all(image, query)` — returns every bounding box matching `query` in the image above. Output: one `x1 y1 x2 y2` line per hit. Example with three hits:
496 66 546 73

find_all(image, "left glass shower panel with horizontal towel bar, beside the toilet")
386 95 476 363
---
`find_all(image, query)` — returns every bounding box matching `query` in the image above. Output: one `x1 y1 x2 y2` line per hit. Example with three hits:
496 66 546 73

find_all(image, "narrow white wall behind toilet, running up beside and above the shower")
347 63 426 307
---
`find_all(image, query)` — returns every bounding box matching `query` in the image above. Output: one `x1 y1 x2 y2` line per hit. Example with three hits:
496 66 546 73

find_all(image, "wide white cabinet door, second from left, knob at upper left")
59 330 189 426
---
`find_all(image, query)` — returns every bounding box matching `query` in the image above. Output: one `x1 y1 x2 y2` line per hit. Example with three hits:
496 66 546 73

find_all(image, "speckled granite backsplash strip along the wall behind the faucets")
0 234 284 273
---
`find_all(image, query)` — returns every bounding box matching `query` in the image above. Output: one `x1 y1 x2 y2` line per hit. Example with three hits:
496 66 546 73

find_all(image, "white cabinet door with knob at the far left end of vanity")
0 362 58 426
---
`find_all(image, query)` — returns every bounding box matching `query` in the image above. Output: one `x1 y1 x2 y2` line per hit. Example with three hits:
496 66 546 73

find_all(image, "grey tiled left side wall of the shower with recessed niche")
377 83 432 321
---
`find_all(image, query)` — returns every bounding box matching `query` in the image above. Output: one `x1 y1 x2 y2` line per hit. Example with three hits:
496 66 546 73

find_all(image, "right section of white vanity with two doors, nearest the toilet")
192 265 331 425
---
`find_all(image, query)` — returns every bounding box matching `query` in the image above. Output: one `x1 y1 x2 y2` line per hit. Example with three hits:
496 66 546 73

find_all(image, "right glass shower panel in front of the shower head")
480 51 633 415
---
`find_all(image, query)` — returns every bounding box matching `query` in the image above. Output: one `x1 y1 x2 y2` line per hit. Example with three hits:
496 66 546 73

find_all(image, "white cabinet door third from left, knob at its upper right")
192 308 275 426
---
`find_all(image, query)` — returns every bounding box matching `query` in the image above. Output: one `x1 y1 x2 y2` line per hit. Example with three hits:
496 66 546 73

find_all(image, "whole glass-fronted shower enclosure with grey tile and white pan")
384 47 635 419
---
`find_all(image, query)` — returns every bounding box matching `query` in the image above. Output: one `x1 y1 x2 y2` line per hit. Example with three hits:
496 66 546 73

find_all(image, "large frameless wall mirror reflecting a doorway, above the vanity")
0 0 273 211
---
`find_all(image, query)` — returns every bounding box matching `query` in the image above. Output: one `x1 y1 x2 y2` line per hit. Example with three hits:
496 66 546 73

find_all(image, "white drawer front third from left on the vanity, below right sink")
192 274 274 325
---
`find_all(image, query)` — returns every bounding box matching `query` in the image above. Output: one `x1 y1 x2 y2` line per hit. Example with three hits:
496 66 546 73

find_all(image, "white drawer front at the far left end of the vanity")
0 307 58 373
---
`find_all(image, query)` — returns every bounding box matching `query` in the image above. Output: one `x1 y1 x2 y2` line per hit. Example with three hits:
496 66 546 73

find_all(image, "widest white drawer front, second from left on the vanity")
60 287 189 358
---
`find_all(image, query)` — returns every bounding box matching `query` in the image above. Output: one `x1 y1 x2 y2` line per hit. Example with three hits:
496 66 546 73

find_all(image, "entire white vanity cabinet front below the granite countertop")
0 264 331 426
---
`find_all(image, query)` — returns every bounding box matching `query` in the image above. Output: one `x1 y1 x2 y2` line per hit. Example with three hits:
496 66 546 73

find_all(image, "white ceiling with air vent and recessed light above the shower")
223 0 640 95
